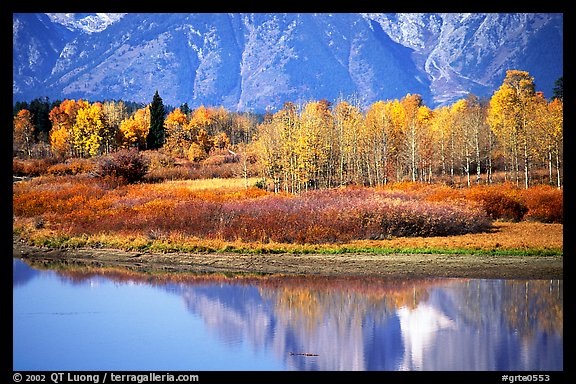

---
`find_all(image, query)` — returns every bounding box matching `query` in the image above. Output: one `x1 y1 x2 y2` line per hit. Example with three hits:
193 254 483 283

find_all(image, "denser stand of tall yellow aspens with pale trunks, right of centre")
256 71 563 192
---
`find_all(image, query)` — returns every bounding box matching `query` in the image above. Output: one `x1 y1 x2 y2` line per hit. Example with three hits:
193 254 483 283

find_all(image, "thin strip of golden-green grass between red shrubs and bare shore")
15 222 563 256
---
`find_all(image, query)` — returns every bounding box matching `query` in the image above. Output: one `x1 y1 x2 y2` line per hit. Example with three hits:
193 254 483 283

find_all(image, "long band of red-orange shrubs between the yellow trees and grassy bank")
13 175 491 243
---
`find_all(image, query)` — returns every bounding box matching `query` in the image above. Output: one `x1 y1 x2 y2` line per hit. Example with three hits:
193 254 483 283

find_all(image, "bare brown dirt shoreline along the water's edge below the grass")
13 241 563 279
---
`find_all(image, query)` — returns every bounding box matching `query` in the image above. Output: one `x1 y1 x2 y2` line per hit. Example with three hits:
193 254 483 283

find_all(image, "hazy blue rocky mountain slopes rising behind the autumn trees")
13 13 563 112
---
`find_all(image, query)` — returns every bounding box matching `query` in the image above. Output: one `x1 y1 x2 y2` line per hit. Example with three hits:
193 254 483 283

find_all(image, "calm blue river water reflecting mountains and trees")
13 259 563 371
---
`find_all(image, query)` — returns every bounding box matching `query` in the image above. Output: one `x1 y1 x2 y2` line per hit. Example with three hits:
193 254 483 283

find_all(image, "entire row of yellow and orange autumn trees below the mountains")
13 70 563 193
